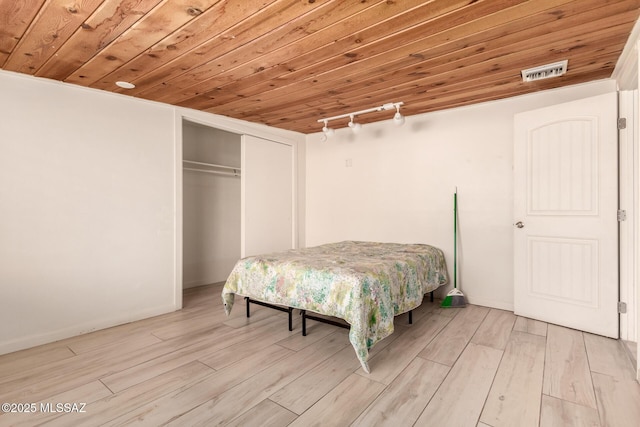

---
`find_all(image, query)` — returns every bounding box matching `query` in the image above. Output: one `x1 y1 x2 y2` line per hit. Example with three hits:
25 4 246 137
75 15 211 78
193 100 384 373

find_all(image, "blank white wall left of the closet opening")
0 72 176 354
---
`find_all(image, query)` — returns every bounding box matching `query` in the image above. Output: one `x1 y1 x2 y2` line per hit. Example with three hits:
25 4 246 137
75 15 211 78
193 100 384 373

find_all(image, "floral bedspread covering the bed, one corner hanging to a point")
222 241 448 373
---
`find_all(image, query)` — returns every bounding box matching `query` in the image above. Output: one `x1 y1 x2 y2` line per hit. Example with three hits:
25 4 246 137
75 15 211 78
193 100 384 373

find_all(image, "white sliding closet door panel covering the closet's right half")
241 135 293 257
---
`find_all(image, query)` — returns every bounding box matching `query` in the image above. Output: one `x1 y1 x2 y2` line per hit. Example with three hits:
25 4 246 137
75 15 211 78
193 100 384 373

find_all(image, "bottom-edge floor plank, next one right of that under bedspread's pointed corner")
352 357 450 427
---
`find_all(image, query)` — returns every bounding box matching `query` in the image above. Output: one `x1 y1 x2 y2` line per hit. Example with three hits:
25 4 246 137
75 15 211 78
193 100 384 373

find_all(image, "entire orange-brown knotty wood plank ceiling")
0 0 640 133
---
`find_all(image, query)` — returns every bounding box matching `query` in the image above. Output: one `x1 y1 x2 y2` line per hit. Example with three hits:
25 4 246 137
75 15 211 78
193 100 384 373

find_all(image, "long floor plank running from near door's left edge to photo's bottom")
480 331 546 427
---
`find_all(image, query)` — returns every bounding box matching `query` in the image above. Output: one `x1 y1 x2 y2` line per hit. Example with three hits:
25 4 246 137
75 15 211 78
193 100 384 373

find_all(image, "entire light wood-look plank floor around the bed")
0 284 640 427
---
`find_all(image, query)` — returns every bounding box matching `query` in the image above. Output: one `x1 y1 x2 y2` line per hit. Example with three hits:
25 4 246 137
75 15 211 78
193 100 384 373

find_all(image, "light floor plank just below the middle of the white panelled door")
543 325 596 409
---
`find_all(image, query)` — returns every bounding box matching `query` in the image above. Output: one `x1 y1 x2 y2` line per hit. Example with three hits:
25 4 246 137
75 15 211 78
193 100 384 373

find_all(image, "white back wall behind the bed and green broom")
304 80 616 310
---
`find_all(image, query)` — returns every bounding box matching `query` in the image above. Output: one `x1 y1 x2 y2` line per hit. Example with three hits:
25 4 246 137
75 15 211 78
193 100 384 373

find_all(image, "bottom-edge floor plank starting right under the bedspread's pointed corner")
290 374 385 427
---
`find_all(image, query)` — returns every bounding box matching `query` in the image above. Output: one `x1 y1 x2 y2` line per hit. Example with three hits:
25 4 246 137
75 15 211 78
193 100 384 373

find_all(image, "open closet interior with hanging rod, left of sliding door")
182 120 242 288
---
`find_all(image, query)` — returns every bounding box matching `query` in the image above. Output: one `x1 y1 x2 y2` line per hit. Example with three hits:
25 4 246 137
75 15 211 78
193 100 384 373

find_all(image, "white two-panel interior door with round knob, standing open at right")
514 93 618 338
